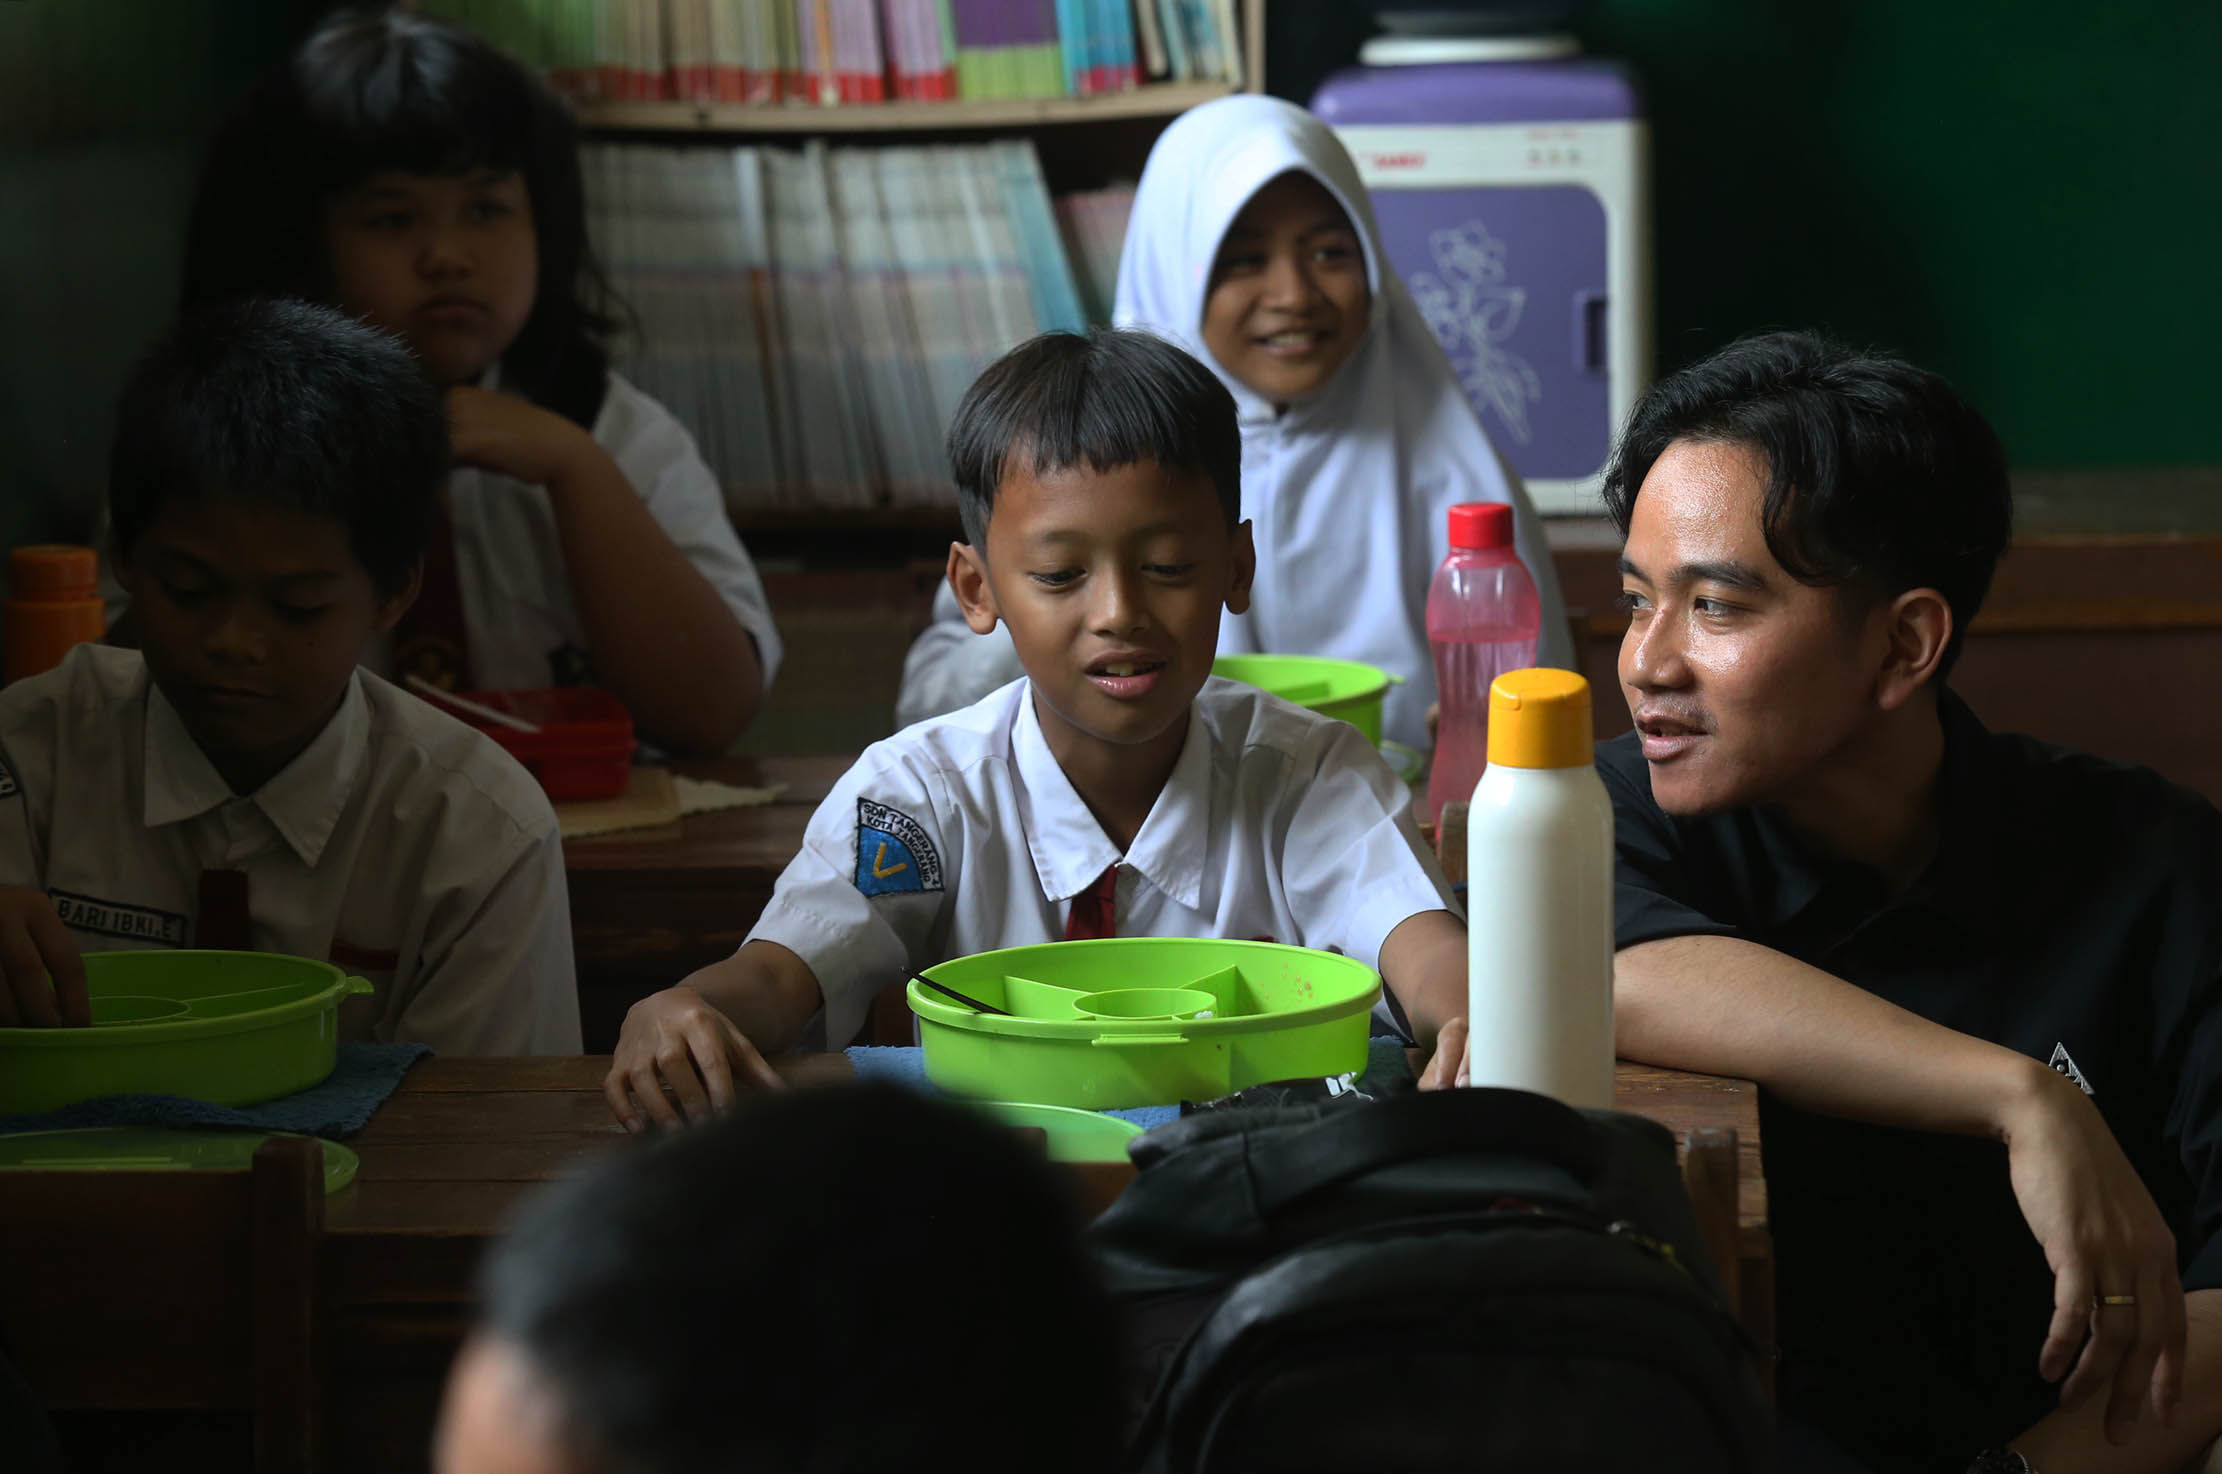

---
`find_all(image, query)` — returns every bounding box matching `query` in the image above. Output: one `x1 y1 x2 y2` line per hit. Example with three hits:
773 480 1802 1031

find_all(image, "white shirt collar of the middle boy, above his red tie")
1011 680 1215 912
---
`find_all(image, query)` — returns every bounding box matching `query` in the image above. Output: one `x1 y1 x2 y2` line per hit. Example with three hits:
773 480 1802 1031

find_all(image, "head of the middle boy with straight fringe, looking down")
949 331 1255 758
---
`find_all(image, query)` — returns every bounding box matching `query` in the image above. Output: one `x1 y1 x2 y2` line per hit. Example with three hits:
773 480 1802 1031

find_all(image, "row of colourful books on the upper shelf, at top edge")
424 0 1242 104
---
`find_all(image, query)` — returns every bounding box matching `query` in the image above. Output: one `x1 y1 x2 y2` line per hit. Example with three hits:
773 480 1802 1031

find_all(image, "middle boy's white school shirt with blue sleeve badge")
749 678 1451 1047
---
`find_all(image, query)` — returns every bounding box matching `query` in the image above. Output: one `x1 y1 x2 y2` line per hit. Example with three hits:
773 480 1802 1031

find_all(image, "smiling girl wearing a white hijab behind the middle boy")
895 96 1573 747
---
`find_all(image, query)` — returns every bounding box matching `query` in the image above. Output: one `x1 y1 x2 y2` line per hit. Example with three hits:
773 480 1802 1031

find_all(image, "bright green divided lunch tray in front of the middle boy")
907 936 1382 1109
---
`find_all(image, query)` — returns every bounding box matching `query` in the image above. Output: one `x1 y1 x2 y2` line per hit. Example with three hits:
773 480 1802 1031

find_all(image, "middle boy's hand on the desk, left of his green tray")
602 983 787 1132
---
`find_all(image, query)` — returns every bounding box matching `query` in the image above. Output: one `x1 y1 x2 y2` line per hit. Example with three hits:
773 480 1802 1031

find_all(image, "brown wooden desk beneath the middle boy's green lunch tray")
322 1054 1773 1472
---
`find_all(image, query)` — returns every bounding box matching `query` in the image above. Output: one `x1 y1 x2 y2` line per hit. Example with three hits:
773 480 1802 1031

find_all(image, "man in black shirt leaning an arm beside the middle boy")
1598 333 2222 1474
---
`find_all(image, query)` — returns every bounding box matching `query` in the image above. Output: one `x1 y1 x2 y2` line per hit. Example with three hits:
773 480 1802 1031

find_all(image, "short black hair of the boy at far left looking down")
109 298 449 596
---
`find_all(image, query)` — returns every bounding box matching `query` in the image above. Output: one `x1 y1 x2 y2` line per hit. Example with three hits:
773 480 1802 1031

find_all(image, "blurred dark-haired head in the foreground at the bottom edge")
436 1085 1118 1474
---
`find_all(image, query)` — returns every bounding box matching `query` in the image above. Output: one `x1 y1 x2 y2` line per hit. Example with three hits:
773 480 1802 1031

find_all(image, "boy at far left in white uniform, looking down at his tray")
0 302 580 1054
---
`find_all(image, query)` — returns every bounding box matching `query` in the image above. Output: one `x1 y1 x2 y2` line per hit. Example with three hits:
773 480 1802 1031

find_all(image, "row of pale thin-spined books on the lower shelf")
582 140 1131 511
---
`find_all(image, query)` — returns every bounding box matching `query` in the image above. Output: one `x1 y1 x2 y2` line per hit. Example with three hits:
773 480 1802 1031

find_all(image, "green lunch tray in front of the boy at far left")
0 952 371 1116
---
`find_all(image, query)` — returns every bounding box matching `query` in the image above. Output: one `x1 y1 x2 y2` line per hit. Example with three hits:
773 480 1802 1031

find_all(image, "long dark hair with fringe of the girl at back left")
182 4 622 429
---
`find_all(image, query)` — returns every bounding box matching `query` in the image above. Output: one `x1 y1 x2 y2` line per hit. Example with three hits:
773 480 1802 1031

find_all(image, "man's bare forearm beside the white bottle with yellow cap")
1613 936 2060 1136
